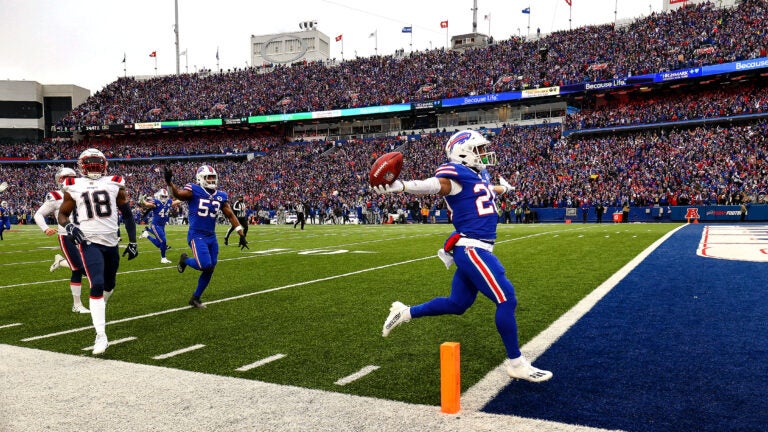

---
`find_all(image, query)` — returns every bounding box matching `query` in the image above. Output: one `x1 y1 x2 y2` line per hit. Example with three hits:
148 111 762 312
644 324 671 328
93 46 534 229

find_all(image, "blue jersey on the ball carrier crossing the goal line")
435 162 499 242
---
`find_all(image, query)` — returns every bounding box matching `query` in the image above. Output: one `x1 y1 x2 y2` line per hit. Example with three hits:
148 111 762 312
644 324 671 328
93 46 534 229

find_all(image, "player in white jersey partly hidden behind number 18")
34 168 90 314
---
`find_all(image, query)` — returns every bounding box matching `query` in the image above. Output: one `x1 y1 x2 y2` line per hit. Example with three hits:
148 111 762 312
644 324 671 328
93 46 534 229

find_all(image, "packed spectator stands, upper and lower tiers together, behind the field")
0 0 768 226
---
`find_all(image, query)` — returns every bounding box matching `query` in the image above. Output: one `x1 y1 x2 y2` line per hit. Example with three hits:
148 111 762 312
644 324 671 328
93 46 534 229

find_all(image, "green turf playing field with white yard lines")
0 224 678 405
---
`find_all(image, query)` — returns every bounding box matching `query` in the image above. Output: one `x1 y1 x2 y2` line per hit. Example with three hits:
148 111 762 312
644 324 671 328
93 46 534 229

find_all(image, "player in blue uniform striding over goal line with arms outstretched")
374 130 552 382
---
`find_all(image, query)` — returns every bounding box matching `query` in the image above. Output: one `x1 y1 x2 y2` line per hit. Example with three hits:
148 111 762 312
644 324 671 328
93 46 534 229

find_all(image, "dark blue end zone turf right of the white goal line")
483 224 768 432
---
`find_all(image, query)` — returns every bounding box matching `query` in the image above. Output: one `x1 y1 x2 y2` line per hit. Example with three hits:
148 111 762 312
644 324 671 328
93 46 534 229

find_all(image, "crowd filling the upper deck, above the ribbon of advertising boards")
55 0 768 127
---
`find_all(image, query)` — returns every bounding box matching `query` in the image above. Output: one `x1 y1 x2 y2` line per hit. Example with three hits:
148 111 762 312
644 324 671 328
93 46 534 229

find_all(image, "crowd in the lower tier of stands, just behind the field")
0 119 768 224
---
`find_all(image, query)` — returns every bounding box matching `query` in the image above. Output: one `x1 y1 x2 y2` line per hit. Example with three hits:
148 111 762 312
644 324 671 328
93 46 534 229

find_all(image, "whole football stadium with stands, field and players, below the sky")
0 0 768 432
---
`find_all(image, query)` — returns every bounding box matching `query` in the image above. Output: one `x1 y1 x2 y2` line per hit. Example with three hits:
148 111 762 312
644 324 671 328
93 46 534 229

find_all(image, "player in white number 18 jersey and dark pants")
59 148 139 354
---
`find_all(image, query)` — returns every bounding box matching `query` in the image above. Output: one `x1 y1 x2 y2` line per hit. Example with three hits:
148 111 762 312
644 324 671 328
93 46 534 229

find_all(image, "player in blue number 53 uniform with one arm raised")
164 165 248 308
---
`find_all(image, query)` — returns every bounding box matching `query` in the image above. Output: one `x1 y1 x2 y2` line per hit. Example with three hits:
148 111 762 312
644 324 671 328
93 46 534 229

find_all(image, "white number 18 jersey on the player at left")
62 176 125 246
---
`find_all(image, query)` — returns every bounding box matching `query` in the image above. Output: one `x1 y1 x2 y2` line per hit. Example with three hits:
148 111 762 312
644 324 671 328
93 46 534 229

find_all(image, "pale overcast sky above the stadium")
0 0 662 94
